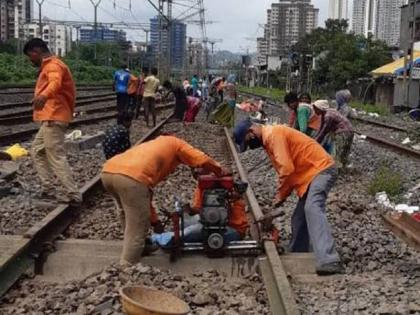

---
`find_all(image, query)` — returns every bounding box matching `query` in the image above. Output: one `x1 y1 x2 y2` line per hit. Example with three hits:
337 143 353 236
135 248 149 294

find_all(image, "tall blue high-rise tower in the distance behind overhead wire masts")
150 17 187 69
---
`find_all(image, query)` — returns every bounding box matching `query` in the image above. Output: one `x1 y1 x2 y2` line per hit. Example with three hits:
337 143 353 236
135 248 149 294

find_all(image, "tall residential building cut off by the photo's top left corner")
0 0 33 41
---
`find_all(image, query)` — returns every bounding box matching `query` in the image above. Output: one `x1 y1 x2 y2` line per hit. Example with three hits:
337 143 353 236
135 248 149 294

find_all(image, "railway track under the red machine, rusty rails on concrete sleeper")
0 116 299 315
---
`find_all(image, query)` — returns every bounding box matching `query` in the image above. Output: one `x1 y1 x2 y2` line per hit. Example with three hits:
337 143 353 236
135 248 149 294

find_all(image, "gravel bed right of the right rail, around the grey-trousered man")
238 107 420 314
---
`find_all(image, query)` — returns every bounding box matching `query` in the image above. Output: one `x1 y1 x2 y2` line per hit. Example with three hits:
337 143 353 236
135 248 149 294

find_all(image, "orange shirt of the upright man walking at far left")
33 56 76 122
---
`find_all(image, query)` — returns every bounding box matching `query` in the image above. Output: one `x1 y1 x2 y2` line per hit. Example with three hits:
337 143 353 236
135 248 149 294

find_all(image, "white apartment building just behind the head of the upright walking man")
23 21 72 57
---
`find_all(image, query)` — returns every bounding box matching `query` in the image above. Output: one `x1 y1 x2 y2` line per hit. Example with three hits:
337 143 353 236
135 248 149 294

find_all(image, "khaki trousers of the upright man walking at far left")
31 121 82 200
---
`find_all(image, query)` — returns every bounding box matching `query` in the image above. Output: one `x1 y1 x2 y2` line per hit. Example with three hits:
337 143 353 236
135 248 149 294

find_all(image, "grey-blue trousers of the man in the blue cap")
290 166 340 266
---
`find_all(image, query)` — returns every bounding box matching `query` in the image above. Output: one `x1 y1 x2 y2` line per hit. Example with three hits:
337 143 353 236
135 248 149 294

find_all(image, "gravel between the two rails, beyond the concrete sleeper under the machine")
65 117 235 240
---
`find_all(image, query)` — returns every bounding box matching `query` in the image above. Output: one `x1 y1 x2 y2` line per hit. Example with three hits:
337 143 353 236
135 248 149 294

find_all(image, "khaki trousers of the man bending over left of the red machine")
101 173 150 264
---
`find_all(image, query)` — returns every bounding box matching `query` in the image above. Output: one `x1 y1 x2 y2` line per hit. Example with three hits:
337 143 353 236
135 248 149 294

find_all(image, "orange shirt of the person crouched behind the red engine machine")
192 187 249 237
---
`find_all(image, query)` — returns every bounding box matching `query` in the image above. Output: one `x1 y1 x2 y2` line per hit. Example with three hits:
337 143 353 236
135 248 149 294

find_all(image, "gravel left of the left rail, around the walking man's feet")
0 110 170 235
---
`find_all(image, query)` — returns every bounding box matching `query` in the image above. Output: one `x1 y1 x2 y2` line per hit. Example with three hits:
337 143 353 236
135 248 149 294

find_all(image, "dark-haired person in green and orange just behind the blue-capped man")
284 92 321 137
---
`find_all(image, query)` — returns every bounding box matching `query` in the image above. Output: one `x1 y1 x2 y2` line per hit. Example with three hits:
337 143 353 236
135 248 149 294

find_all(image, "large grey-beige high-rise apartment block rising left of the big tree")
258 0 319 60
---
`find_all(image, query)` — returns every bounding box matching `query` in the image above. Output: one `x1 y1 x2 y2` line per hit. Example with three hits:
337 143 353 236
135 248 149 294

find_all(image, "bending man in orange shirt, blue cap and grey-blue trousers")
234 120 343 275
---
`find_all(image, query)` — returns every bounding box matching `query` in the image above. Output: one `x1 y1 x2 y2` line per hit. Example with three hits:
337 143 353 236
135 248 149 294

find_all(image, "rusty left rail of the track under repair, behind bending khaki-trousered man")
0 114 173 296
